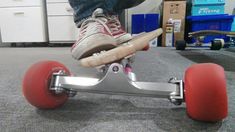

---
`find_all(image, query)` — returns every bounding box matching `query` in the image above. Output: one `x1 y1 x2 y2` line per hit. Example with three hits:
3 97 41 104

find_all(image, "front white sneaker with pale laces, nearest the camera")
71 9 117 60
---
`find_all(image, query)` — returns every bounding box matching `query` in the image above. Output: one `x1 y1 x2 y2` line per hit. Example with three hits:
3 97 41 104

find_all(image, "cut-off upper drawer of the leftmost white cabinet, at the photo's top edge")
0 0 42 7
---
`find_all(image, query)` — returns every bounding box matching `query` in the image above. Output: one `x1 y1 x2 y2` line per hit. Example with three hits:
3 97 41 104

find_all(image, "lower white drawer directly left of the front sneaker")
48 16 78 42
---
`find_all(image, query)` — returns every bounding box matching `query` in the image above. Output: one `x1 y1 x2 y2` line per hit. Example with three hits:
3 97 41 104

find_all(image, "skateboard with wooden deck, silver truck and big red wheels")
22 29 228 122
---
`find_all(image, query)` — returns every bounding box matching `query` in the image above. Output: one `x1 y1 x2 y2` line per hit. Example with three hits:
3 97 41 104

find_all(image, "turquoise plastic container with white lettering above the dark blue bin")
191 0 225 16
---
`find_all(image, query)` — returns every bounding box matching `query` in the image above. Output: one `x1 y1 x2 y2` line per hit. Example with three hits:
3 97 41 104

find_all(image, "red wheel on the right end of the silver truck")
185 63 228 122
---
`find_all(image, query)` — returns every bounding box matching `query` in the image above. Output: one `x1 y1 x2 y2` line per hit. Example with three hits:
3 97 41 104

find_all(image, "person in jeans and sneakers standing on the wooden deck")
69 0 144 60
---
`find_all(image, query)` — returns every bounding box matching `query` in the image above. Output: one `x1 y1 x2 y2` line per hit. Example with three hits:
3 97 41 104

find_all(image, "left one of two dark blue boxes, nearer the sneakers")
131 14 145 34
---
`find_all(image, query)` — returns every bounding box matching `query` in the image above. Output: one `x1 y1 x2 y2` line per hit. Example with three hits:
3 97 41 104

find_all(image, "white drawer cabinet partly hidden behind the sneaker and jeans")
47 0 78 43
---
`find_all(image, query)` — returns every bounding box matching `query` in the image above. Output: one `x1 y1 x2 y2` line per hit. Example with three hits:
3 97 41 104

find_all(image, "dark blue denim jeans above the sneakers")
69 0 144 26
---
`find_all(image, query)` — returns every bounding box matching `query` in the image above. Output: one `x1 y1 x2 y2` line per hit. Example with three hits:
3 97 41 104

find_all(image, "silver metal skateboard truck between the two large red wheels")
49 63 184 105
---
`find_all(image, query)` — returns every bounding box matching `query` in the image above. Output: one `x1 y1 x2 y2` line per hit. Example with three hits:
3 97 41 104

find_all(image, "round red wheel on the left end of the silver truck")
23 61 70 109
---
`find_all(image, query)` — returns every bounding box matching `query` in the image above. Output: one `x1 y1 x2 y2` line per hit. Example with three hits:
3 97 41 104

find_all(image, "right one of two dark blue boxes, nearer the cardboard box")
145 14 159 32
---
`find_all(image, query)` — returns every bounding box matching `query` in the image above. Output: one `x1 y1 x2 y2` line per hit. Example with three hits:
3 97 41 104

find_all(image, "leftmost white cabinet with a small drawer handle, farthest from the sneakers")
0 0 47 43
